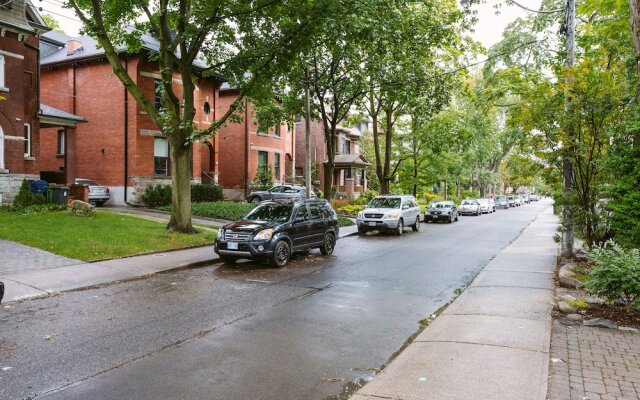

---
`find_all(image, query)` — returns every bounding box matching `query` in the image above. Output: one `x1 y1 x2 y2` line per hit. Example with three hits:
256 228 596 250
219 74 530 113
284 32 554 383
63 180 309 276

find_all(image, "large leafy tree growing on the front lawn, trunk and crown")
69 0 331 233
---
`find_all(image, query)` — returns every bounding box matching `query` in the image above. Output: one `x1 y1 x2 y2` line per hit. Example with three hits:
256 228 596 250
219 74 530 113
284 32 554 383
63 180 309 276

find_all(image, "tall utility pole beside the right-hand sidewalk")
560 0 576 256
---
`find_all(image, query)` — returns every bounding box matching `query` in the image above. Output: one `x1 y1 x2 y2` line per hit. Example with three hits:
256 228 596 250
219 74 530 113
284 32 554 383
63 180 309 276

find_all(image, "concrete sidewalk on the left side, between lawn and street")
0 222 358 303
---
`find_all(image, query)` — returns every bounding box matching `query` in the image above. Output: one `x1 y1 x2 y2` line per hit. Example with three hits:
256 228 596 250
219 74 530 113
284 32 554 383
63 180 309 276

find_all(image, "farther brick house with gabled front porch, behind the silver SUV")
296 118 371 198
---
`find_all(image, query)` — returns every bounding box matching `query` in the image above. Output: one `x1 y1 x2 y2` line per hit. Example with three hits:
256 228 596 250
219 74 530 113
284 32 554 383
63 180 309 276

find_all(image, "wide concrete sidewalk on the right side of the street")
351 207 558 400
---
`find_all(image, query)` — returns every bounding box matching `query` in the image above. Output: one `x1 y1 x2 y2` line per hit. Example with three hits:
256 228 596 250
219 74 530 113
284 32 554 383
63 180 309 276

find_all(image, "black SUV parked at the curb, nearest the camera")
214 199 339 267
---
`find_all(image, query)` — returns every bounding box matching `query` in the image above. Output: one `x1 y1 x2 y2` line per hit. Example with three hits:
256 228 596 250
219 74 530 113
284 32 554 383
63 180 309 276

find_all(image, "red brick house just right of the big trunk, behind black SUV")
212 83 296 199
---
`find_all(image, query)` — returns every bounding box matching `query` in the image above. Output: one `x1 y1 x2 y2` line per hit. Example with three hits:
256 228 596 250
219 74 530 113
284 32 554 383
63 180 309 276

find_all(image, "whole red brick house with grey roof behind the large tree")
40 32 222 204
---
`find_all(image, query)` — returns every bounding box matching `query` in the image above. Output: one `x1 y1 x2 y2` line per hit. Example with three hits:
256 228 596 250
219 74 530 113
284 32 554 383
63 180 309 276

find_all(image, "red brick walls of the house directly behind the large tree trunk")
41 34 221 204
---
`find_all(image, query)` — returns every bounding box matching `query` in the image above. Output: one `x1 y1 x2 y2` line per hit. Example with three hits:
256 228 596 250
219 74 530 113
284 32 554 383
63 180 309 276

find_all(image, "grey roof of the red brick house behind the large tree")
40 31 221 78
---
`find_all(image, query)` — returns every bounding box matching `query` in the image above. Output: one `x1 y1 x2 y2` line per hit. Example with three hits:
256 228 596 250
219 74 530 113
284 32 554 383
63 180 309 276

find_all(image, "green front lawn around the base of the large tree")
0 210 216 261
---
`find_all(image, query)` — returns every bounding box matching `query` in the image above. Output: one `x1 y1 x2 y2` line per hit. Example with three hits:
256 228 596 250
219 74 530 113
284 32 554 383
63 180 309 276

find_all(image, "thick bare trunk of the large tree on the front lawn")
167 134 195 233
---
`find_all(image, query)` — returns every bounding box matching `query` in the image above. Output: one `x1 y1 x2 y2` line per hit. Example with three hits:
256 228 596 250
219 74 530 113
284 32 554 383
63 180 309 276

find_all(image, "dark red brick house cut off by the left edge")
0 0 83 204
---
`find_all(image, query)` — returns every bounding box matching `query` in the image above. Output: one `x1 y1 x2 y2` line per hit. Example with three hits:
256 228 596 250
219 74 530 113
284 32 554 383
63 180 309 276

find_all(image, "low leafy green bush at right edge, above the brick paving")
585 241 640 308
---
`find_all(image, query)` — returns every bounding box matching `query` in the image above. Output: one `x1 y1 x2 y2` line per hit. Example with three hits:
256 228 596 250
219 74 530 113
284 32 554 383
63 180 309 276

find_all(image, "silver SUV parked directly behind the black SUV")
356 195 420 235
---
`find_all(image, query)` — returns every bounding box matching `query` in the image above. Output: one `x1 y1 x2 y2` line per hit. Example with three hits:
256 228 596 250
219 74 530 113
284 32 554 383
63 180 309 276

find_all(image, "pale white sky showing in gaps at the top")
37 0 541 48
